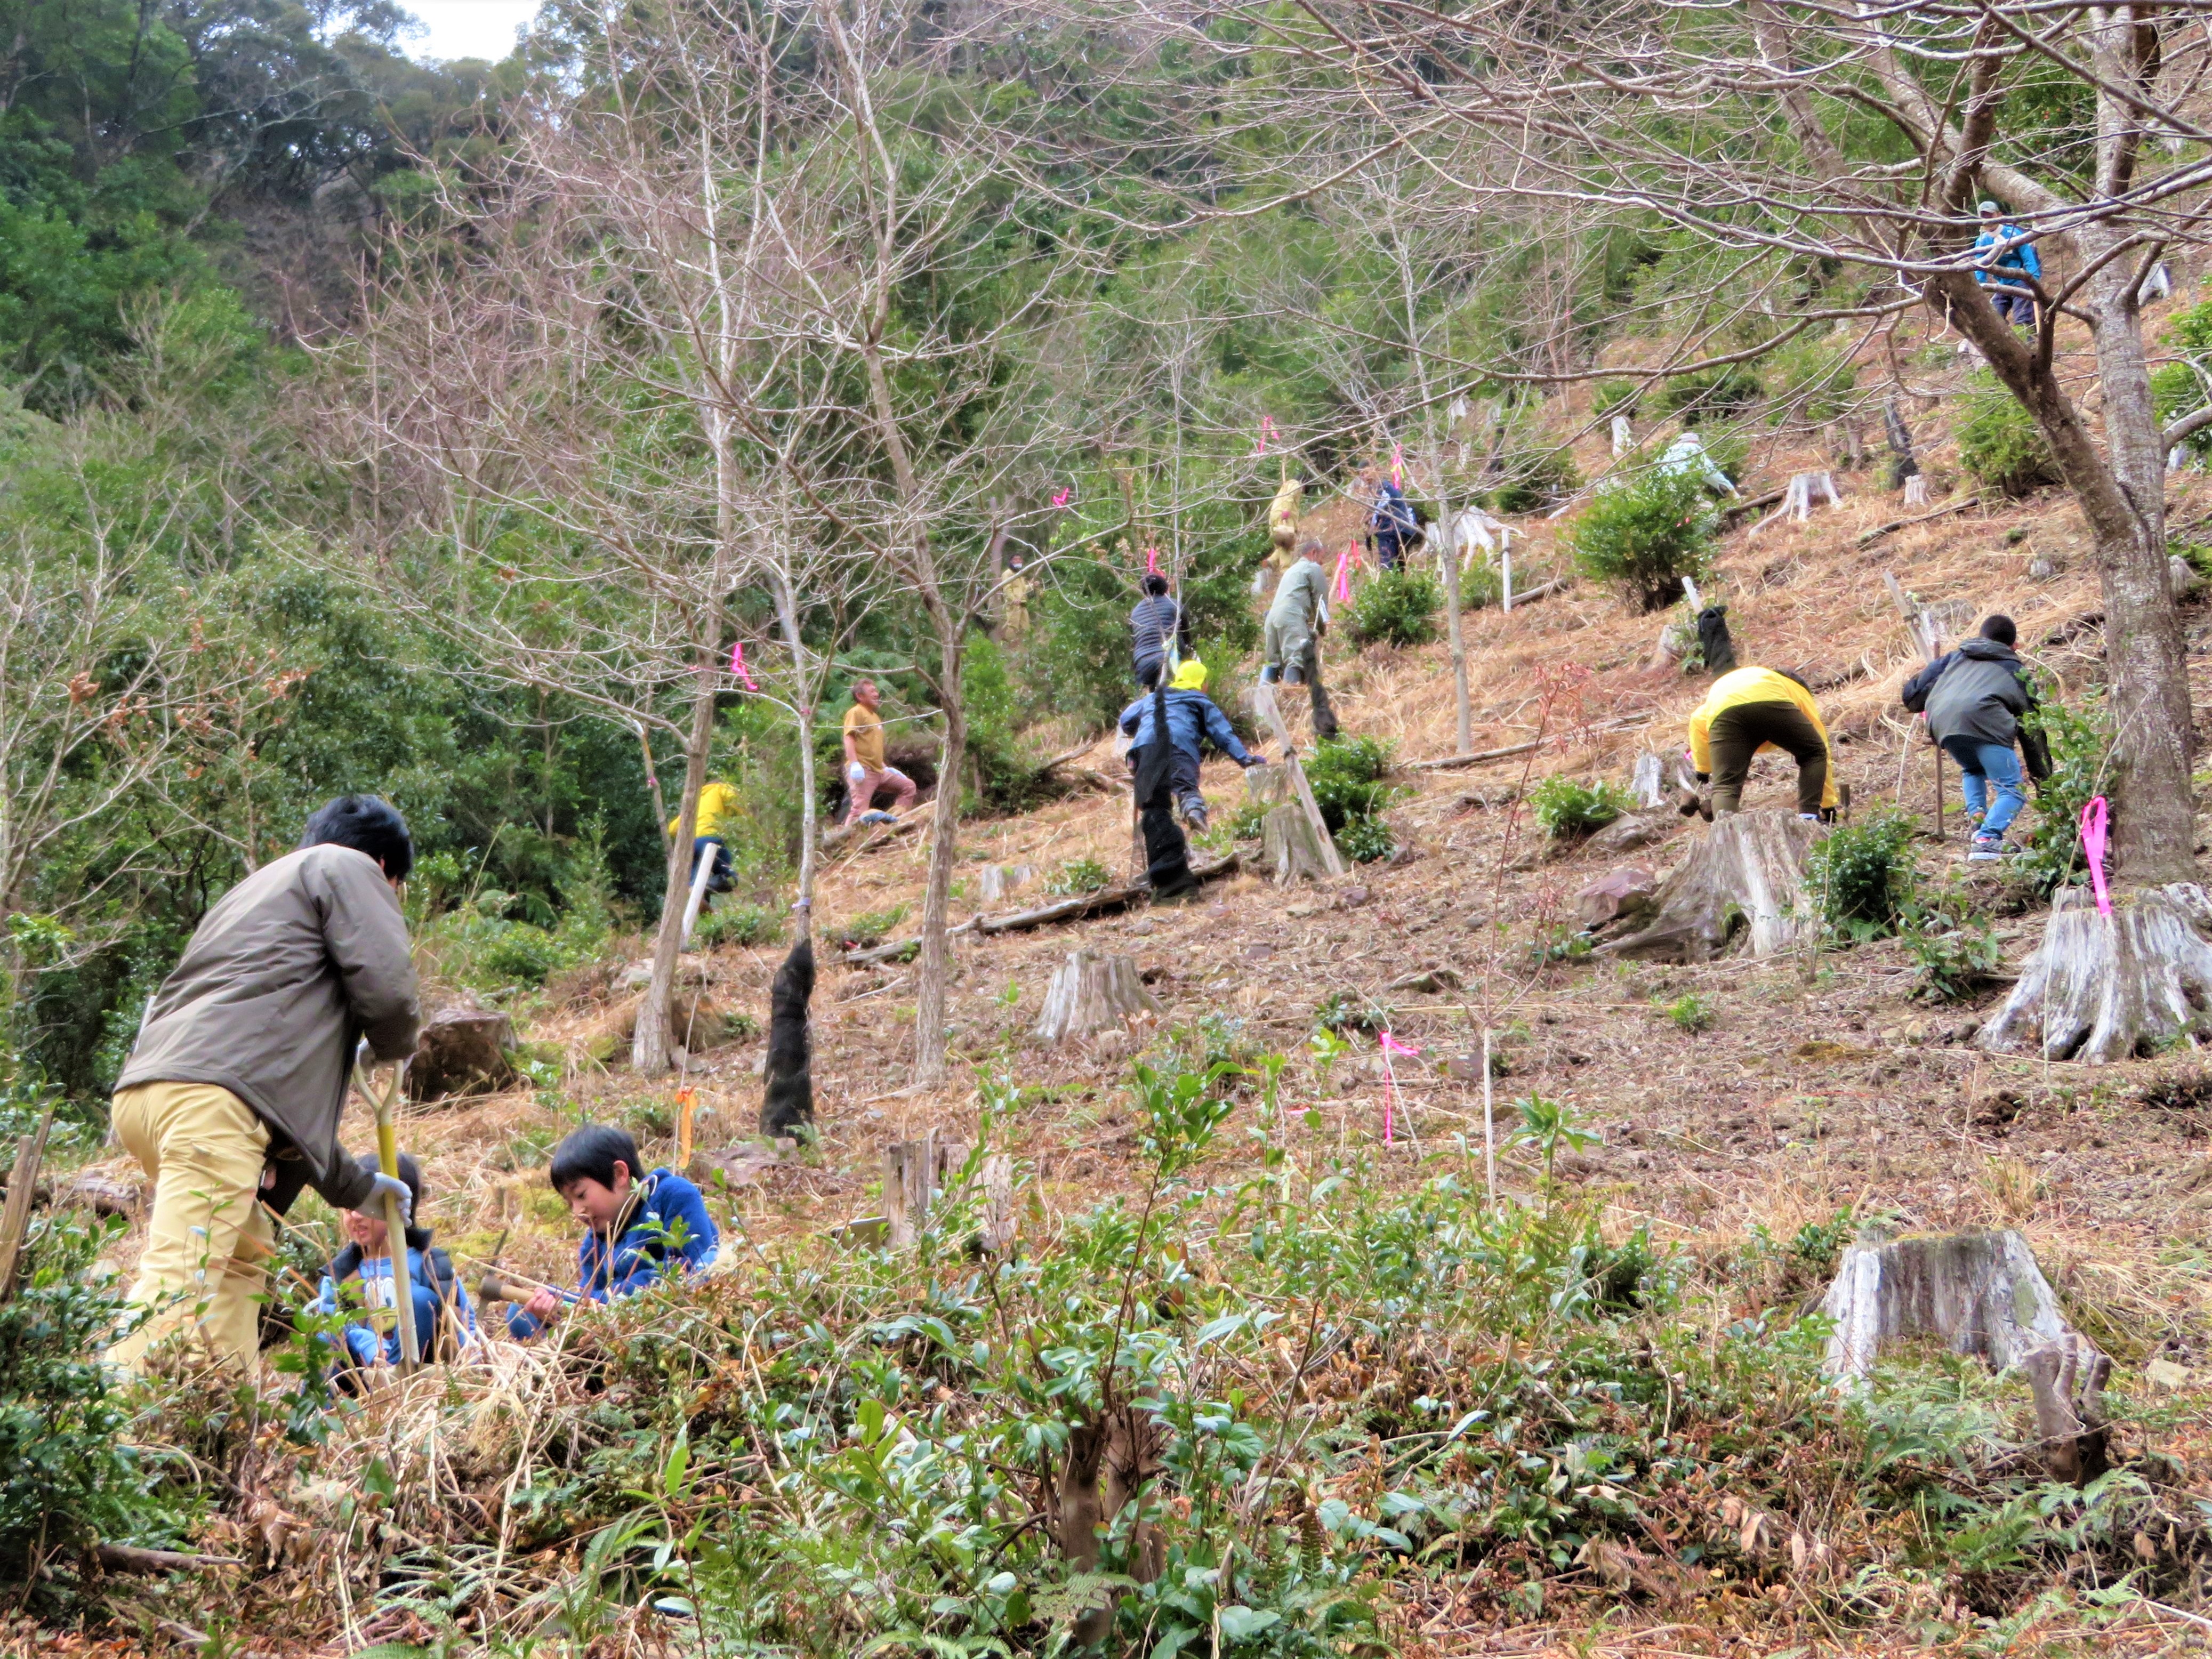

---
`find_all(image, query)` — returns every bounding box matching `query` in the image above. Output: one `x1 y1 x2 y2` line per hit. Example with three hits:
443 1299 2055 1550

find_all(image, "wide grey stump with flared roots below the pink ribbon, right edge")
1975 883 2212 1066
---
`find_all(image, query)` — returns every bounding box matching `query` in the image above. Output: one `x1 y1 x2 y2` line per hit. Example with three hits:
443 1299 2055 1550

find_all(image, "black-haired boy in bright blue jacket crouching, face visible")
506 1124 721 1338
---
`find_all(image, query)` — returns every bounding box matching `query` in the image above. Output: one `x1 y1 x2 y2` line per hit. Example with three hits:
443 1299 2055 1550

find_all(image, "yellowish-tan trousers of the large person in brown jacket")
108 1084 277 1372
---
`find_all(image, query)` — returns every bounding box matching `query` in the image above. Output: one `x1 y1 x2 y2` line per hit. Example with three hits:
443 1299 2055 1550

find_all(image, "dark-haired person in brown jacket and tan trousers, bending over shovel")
108 794 420 1369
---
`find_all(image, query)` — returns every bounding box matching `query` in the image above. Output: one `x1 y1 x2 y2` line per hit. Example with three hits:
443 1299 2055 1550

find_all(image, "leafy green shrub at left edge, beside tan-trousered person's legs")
0 1212 179 1586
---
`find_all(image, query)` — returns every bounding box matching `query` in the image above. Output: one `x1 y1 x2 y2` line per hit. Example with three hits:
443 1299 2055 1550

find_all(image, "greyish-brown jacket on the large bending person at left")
115 845 420 1210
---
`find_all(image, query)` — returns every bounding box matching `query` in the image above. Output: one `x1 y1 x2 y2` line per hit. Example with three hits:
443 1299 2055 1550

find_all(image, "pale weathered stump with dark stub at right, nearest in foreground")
1821 1230 2112 1484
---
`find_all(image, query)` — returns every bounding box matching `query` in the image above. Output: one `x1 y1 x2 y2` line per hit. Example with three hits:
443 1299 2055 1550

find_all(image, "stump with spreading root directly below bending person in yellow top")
1599 812 1821 962
